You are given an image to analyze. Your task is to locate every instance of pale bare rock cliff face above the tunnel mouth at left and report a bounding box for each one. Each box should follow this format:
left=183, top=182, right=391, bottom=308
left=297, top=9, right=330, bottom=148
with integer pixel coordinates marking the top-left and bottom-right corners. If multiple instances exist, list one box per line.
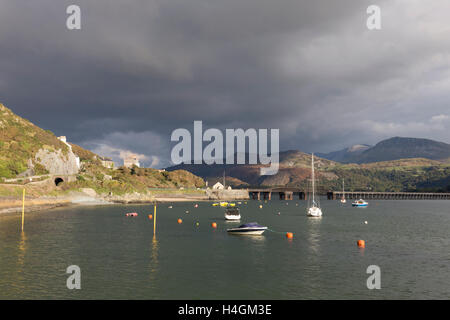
left=35, top=148, right=80, bottom=175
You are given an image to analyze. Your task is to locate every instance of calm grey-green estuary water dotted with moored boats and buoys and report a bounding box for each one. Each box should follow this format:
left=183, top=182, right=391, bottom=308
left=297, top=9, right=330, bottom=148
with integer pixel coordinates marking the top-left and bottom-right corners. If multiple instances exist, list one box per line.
left=0, top=200, right=450, bottom=299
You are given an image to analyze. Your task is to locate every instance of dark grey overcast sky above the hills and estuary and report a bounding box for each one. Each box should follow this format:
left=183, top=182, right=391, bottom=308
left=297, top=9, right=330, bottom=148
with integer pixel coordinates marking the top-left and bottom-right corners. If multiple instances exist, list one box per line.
left=0, top=0, right=450, bottom=167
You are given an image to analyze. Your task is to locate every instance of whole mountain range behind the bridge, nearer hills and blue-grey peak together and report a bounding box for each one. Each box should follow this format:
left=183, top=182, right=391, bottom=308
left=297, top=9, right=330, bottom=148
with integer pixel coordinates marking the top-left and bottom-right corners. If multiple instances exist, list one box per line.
left=167, top=137, right=450, bottom=191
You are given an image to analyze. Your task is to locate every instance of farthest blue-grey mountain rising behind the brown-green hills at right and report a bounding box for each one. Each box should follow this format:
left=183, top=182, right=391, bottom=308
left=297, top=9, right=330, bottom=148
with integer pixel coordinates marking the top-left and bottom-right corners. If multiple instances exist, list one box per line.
left=317, top=137, right=450, bottom=163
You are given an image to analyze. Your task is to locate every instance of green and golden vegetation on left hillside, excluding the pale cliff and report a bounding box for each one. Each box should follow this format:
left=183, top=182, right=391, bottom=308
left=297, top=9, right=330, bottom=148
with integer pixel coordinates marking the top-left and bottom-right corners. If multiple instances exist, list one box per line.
left=0, top=104, right=205, bottom=196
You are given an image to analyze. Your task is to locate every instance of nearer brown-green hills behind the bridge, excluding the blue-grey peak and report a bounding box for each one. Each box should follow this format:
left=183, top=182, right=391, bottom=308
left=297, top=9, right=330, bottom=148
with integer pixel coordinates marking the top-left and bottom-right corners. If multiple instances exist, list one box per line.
left=168, top=151, right=450, bottom=192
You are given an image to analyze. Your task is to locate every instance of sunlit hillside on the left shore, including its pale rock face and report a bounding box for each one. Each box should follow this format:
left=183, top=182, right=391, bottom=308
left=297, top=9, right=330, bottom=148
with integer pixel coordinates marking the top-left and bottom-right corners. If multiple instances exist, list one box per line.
left=0, top=104, right=205, bottom=196
